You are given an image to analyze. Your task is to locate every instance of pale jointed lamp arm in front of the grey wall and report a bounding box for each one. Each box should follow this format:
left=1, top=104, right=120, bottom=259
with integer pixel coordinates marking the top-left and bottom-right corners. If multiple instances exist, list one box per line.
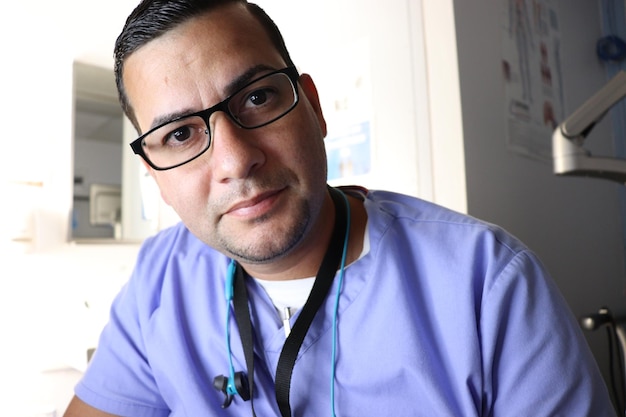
left=552, top=71, right=626, bottom=184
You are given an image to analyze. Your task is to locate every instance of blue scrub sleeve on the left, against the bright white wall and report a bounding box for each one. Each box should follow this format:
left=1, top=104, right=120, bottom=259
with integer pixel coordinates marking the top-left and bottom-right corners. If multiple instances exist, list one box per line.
left=75, top=264, right=170, bottom=417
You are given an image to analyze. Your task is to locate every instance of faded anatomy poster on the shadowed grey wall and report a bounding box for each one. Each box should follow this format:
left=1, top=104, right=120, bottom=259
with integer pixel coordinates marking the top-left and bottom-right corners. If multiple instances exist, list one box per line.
left=502, top=0, right=563, bottom=161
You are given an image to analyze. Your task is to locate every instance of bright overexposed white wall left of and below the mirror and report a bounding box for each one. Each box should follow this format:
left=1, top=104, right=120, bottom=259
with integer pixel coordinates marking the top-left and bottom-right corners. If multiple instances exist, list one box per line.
left=0, top=2, right=137, bottom=417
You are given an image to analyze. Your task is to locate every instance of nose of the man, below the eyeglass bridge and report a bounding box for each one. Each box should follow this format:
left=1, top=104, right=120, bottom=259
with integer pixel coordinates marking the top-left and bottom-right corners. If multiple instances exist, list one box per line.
left=209, top=112, right=266, bottom=182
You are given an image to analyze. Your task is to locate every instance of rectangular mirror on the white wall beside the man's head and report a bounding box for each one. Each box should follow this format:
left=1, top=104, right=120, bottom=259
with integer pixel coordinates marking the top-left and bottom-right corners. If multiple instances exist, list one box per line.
left=70, top=62, right=124, bottom=240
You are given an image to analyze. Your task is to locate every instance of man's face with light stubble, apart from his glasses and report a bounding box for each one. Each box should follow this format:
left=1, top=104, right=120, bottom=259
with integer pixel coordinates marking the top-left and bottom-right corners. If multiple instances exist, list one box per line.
left=123, top=5, right=326, bottom=263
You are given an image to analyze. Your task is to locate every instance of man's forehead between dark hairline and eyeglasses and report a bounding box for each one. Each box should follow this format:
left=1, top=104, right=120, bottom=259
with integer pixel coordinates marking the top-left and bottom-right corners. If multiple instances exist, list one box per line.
left=123, top=4, right=285, bottom=131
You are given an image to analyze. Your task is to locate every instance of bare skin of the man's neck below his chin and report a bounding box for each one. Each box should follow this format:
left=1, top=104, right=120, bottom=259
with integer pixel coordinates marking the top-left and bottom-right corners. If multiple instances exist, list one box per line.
left=241, top=188, right=367, bottom=281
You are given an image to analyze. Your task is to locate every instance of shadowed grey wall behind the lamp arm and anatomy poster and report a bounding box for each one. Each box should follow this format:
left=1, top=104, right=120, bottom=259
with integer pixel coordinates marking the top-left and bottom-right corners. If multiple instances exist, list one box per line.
left=454, top=0, right=626, bottom=386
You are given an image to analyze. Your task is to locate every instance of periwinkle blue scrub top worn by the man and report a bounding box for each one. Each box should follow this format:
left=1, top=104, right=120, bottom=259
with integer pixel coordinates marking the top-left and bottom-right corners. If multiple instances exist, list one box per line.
left=76, top=191, right=614, bottom=417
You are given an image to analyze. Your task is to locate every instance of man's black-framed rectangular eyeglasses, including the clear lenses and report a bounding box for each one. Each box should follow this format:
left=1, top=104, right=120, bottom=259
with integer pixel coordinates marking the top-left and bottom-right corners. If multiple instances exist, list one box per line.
left=130, top=67, right=298, bottom=171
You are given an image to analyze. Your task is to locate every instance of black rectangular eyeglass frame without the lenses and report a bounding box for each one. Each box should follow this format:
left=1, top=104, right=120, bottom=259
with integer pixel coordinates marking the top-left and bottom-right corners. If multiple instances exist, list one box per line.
left=130, top=66, right=300, bottom=171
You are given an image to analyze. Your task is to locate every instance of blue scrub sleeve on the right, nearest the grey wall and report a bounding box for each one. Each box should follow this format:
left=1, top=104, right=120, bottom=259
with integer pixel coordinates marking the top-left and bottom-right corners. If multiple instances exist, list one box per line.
left=480, top=251, right=615, bottom=417
